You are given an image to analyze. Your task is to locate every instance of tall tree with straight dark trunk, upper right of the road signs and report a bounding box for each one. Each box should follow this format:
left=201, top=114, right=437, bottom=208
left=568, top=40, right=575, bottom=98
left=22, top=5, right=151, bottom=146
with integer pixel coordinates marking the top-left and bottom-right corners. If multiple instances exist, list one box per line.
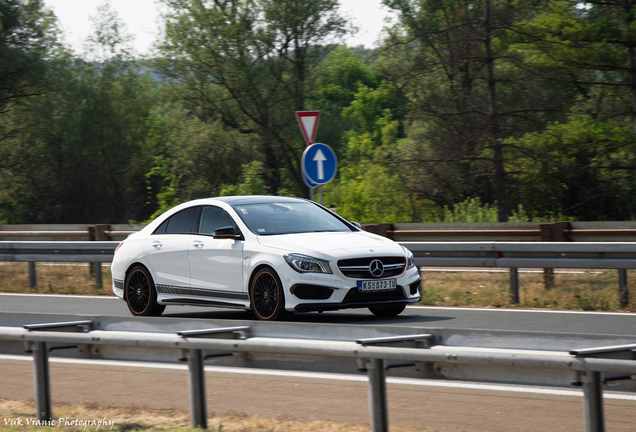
left=380, top=0, right=559, bottom=221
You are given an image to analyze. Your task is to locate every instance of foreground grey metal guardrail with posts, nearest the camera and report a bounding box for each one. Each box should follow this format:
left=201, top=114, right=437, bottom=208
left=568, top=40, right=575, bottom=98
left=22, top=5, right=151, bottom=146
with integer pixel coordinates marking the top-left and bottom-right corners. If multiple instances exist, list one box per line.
left=0, top=320, right=636, bottom=432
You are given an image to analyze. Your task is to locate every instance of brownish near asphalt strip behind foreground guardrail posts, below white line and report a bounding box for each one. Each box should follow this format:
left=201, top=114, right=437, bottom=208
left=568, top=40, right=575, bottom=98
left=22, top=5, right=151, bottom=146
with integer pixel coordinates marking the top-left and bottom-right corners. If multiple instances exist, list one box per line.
left=0, top=359, right=636, bottom=432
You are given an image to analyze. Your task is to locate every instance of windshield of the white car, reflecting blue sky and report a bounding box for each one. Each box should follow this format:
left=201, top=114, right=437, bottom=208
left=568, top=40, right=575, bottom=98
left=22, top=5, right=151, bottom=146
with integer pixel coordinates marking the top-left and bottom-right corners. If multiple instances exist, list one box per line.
left=234, top=202, right=351, bottom=235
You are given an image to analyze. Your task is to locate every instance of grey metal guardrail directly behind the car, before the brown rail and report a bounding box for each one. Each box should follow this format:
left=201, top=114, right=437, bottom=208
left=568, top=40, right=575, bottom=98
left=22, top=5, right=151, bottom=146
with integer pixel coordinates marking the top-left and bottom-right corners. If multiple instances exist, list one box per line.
left=0, top=241, right=636, bottom=307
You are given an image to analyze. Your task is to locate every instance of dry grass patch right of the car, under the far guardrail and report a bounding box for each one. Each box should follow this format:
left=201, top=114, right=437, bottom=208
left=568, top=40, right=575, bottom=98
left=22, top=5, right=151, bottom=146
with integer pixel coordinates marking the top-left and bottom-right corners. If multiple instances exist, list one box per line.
left=422, top=270, right=636, bottom=312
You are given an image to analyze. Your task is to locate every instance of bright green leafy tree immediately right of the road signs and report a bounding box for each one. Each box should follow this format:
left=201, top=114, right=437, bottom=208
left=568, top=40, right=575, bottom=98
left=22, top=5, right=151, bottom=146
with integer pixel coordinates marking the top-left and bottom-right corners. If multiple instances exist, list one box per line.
left=325, top=68, right=433, bottom=223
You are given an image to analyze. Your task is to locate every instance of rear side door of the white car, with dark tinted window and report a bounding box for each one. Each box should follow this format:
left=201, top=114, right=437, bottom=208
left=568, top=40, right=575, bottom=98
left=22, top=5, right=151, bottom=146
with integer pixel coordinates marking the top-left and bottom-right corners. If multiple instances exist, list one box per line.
left=144, top=206, right=200, bottom=295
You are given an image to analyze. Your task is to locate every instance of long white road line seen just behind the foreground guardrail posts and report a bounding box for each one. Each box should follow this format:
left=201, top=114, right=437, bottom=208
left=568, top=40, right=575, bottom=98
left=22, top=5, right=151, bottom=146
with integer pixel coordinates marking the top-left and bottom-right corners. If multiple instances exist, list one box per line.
left=0, top=354, right=636, bottom=401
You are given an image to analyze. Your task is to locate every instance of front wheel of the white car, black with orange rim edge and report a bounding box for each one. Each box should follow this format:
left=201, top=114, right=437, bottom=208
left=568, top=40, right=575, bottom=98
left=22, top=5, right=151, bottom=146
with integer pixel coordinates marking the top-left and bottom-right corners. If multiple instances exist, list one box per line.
left=250, top=267, right=291, bottom=321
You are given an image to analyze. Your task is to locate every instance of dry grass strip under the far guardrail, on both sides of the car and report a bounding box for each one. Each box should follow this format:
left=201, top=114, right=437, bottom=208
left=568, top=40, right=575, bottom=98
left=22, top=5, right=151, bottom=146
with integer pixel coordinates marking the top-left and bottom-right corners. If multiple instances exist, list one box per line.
left=0, top=263, right=636, bottom=312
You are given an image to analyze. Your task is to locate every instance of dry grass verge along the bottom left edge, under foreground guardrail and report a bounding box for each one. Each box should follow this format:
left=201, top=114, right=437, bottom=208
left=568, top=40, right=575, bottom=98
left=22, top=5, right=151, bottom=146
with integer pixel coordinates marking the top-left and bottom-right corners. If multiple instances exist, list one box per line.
left=0, top=399, right=424, bottom=432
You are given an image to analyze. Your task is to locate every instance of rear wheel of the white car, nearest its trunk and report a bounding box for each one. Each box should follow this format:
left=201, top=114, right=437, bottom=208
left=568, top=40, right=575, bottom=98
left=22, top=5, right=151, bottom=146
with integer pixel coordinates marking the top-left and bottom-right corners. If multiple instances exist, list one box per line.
left=124, top=265, right=166, bottom=316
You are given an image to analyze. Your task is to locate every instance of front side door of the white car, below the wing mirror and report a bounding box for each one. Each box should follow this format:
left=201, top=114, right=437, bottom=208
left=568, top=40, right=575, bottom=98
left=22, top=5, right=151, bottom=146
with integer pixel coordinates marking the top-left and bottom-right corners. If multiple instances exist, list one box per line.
left=188, top=206, right=248, bottom=302
